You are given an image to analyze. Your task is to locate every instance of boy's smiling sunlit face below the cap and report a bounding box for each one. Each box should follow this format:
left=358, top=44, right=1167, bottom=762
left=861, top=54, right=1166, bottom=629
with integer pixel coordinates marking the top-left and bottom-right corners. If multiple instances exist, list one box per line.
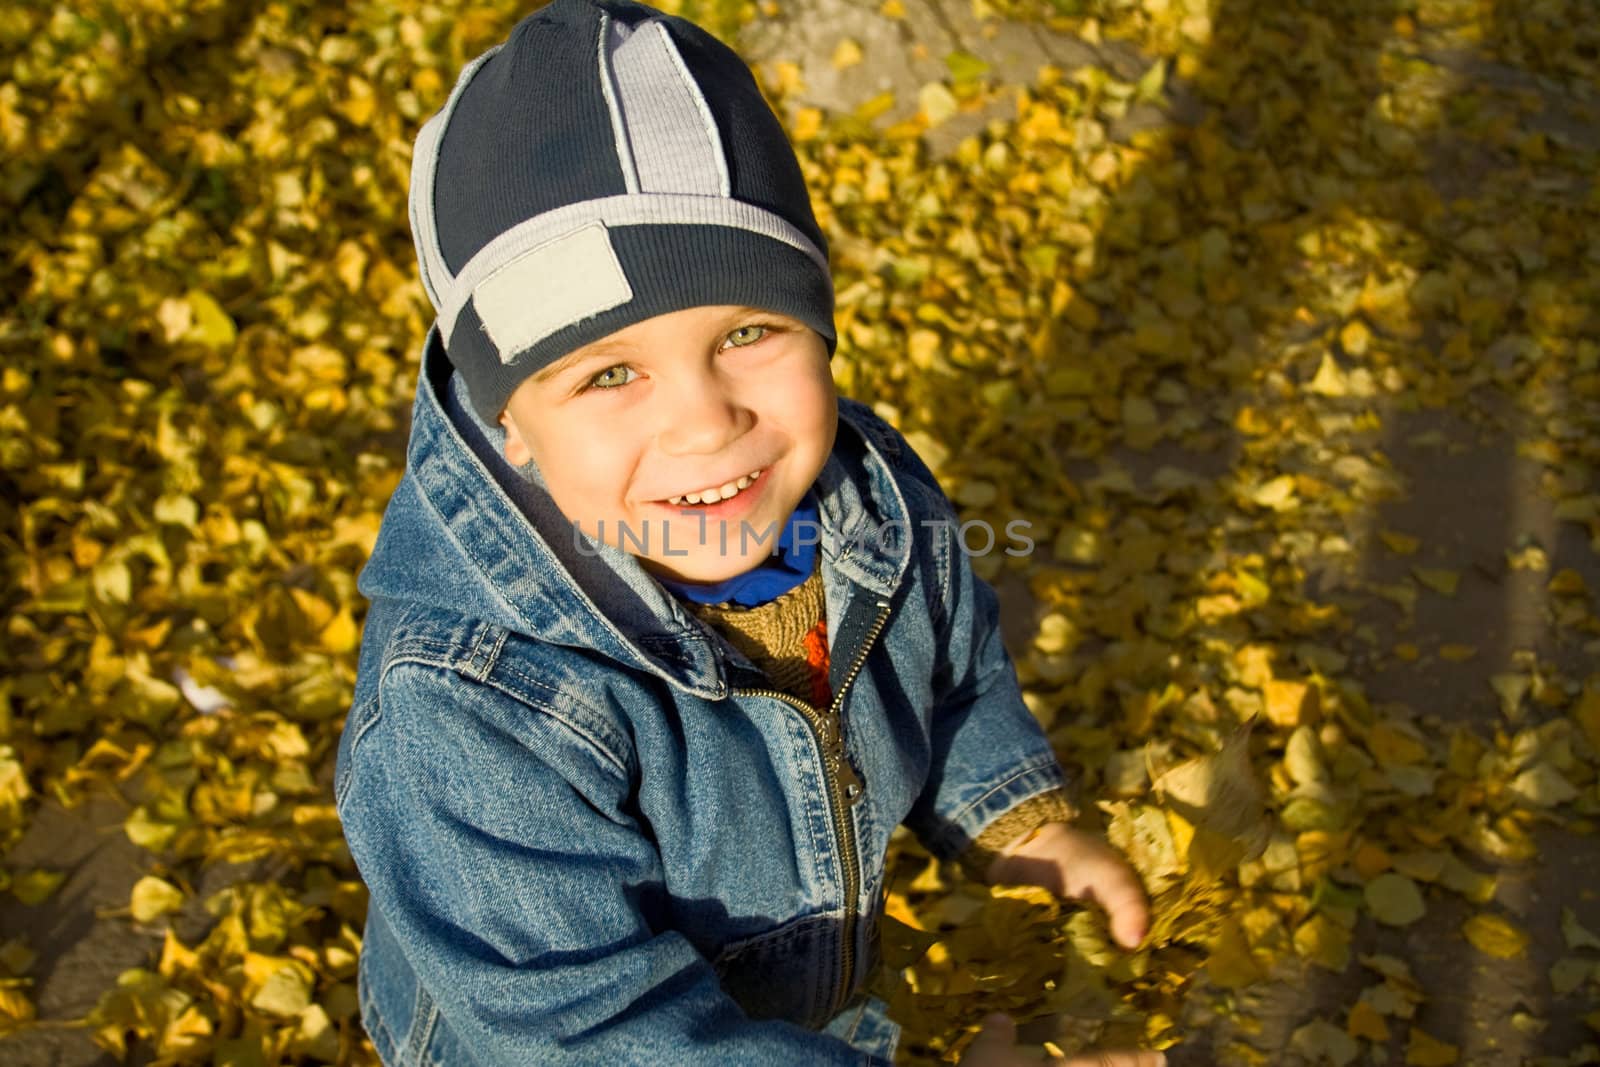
left=501, top=306, right=838, bottom=582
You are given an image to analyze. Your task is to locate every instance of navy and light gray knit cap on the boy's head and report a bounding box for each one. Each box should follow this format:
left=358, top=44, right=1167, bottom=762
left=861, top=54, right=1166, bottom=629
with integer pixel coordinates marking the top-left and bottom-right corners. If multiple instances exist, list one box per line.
left=411, top=0, right=835, bottom=422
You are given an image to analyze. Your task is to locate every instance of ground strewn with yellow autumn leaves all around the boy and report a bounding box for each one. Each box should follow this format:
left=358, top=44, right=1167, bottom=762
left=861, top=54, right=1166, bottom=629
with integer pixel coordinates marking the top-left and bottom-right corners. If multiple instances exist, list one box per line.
left=0, top=0, right=1600, bottom=1065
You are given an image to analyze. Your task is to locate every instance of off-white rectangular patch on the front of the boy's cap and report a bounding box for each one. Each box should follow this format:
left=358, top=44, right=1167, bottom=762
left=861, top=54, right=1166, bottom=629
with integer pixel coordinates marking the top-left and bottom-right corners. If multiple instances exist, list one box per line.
left=472, top=222, right=634, bottom=363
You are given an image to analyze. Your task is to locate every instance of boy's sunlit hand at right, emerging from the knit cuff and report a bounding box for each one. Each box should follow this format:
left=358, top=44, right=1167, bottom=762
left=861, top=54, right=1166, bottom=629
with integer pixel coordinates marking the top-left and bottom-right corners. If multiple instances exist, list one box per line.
left=986, top=822, right=1150, bottom=953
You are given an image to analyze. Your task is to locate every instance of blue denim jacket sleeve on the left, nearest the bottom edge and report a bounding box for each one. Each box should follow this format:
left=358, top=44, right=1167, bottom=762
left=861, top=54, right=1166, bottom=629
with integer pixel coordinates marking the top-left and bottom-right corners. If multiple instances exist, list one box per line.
left=339, top=664, right=877, bottom=1067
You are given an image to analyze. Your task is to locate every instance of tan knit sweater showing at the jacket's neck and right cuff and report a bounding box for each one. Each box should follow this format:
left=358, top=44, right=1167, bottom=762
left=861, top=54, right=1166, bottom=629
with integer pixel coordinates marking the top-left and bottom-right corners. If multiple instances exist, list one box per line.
left=683, top=569, right=1077, bottom=880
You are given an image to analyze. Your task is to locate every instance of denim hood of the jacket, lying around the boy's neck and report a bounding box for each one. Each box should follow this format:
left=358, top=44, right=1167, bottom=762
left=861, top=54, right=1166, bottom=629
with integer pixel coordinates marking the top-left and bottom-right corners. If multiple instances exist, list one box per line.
left=358, top=330, right=910, bottom=701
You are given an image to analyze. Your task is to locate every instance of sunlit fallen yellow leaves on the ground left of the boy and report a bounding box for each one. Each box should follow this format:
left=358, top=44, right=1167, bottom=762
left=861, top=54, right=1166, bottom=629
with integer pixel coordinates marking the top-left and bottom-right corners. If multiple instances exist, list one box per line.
left=0, top=0, right=534, bottom=1064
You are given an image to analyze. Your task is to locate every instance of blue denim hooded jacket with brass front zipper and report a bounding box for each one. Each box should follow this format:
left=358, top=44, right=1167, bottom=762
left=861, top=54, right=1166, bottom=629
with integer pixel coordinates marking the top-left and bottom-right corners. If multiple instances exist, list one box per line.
left=334, top=334, right=1062, bottom=1067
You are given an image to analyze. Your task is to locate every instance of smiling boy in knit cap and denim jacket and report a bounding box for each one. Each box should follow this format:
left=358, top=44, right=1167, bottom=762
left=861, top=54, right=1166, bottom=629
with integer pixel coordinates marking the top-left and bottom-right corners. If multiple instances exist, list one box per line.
left=336, top=0, right=1158, bottom=1065
